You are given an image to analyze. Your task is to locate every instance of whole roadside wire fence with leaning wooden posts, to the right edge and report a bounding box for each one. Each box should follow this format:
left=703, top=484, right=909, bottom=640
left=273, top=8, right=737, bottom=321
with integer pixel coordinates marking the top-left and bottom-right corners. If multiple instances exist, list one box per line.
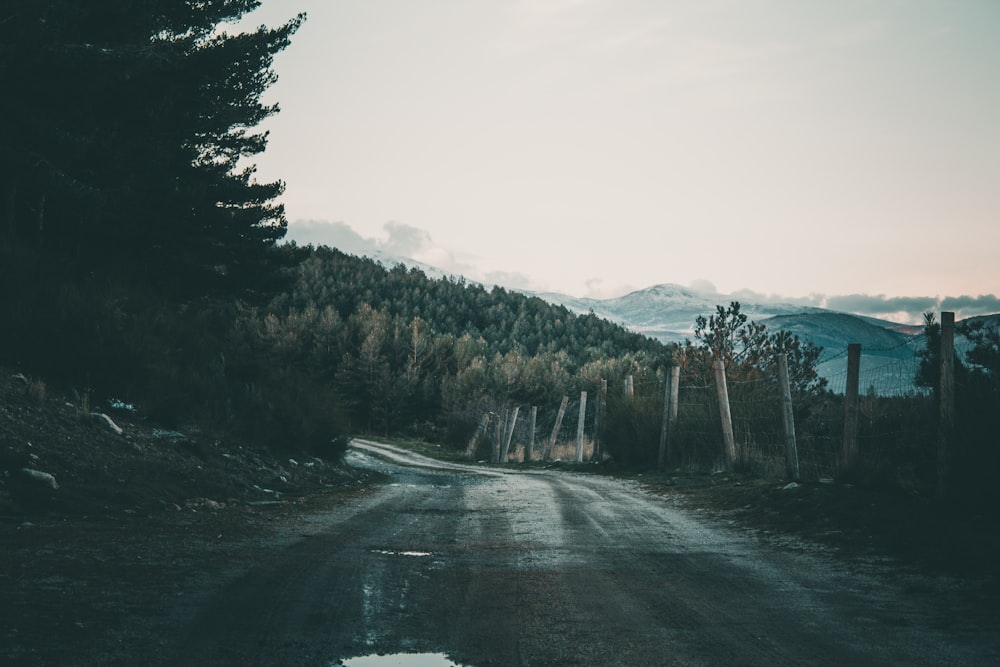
left=470, top=318, right=1000, bottom=500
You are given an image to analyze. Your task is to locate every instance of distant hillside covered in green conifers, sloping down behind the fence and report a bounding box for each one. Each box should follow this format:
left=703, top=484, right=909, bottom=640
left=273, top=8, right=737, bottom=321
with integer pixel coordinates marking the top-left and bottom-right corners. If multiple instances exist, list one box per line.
left=254, top=248, right=669, bottom=445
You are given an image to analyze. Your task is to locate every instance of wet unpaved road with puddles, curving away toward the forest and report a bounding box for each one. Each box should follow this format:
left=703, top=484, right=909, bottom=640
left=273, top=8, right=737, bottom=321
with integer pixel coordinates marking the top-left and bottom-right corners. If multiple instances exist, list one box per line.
left=169, top=441, right=1000, bottom=667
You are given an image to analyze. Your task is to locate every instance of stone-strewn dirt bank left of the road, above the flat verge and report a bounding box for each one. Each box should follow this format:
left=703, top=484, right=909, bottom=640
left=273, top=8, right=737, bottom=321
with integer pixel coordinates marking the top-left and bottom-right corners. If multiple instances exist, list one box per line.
left=0, top=368, right=360, bottom=519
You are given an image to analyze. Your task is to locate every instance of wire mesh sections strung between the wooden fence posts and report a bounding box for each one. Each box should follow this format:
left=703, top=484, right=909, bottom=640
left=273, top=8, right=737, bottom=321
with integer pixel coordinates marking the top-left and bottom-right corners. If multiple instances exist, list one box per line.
left=470, top=343, right=934, bottom=481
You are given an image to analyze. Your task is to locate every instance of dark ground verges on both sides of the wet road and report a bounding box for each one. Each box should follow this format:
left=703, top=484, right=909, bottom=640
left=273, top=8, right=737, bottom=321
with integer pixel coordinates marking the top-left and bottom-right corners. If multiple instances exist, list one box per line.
left=0, top=370, right=1000, bottom=665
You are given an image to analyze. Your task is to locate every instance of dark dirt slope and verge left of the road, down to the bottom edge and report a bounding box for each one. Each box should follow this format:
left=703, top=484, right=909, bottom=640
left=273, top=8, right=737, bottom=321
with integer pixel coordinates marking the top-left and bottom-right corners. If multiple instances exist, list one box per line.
left=0, top=367, right=367, bottom=665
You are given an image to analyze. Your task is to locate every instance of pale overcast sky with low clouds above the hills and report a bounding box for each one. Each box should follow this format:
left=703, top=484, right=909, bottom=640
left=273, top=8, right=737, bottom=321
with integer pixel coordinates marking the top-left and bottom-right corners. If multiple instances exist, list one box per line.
left=236, top=0, right=1000, bottom=321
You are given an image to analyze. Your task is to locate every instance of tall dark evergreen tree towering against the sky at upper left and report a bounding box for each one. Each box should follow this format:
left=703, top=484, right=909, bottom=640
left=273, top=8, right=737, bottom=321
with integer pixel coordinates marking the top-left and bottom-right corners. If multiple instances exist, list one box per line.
left=0, top=0, right=304, bottom=291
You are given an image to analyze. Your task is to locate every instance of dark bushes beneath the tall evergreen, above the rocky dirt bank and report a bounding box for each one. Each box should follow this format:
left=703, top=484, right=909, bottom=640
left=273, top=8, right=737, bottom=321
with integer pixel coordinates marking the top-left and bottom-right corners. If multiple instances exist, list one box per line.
left=0, top=250, right=346, bottom=460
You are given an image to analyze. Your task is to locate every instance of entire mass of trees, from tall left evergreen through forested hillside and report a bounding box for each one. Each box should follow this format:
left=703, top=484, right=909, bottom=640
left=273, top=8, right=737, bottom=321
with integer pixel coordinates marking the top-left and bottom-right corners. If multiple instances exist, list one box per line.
left=0, top=0, right=680, bottom=464
